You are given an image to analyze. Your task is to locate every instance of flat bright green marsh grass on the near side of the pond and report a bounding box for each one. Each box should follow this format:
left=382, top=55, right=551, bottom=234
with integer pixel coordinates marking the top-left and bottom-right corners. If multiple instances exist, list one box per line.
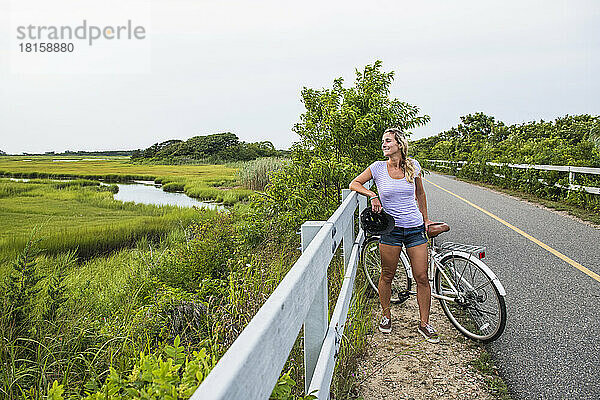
left=0, top=179, right=211, bottom=275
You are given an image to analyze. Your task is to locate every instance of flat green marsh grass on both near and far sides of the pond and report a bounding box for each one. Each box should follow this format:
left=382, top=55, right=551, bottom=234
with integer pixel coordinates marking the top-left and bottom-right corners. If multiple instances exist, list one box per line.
left=0, top=157, right=252, bottom=266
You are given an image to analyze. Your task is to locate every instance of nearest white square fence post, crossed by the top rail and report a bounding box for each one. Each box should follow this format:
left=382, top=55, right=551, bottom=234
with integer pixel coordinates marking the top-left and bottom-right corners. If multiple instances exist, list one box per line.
left=300, top=221, right=329, bottom=391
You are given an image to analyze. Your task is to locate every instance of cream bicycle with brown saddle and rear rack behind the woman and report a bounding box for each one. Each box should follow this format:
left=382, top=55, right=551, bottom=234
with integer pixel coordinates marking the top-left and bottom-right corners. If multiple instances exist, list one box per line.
left=361, top=223, right=506, bottom=343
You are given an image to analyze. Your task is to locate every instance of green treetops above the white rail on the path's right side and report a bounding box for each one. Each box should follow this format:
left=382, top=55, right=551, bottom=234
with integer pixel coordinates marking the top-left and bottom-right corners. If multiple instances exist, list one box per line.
left=412, top=113, right=600, bottom=166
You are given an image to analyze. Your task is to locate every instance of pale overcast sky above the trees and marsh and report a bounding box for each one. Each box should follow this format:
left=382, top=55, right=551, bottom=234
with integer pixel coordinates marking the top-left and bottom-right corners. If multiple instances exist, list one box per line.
left=0, top=0, right=600, bottom=153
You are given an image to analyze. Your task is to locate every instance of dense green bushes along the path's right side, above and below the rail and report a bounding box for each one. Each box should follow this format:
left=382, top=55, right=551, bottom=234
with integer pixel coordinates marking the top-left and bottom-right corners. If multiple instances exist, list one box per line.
left=411, top=113, right=600, bottom=214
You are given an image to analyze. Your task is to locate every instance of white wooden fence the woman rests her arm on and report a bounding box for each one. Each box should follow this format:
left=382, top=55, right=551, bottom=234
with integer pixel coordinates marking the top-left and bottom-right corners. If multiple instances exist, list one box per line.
left=191, top=183, right=370, bottom=400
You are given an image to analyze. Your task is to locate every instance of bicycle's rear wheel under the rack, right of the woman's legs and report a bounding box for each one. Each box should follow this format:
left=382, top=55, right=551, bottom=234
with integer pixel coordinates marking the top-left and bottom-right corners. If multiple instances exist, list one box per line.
left=434, top=253, right=506, bottom=343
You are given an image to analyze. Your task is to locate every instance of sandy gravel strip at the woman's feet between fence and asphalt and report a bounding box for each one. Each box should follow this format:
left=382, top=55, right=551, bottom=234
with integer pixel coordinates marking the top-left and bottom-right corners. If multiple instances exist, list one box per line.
left=359, top=296, right=494, bottom=400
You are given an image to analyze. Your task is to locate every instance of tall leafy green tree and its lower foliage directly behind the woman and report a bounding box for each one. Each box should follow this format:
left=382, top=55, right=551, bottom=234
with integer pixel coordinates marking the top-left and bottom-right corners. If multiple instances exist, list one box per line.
left=264, top=61, right=429, bottom=226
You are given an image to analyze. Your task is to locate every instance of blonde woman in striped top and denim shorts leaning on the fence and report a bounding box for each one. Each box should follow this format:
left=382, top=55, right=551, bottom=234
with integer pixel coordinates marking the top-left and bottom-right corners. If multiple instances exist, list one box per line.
left=350, top=128, right=439, bottom=343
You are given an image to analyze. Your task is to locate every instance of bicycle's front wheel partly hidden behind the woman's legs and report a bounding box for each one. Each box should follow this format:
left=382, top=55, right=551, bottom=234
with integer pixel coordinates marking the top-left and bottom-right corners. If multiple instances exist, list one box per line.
left=361, top=237, right=412, bottom=304
